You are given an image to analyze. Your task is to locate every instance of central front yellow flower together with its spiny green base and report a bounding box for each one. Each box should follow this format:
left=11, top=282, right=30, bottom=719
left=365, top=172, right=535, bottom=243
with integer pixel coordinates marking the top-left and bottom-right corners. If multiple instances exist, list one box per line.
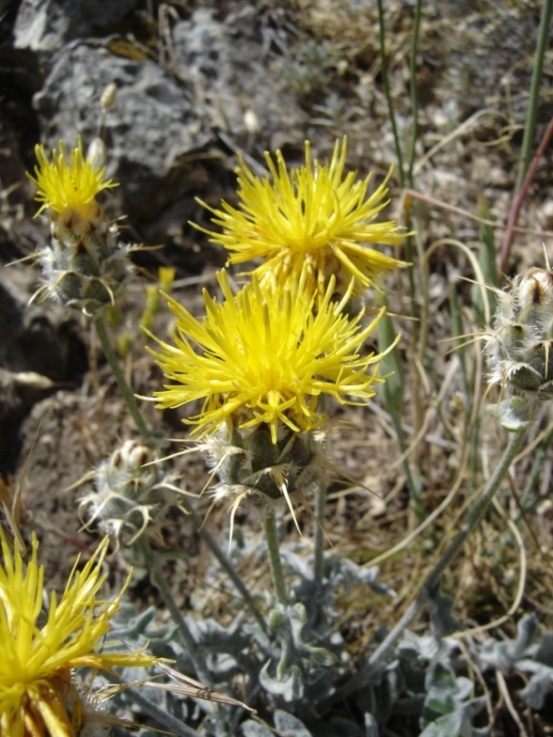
left=149, top=270, right=394, bottom=540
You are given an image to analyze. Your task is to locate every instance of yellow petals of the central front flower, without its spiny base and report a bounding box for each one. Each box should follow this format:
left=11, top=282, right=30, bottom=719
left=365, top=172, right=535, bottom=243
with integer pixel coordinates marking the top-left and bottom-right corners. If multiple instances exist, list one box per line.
left=152, top=271, right=394, bottom=443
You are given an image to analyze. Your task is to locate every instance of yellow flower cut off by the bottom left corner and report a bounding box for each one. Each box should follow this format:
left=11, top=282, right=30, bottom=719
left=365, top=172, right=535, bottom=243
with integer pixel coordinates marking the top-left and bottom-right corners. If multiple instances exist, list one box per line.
left=0, top=531, right=156, bottom=737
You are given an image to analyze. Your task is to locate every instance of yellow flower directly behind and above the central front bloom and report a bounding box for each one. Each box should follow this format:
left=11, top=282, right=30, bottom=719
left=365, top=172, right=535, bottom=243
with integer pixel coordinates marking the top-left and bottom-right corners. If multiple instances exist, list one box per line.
left=195, top=138, right=408, bottom=299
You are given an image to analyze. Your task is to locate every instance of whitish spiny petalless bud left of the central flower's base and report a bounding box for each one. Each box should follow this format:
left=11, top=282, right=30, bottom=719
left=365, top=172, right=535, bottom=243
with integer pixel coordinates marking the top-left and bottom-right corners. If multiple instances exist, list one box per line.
left=79, top=440, right=183, bottom=545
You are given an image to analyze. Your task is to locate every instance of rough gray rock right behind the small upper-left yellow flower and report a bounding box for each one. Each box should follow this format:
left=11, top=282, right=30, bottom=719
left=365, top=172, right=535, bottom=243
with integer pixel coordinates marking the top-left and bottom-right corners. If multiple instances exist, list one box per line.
left=34, top=42, right=210, bottom=207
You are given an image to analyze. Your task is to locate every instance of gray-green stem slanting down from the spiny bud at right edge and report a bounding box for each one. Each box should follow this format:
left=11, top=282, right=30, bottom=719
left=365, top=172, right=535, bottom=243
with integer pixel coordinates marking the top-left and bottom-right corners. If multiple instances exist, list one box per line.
left=367, top=428, right=526, bottom=670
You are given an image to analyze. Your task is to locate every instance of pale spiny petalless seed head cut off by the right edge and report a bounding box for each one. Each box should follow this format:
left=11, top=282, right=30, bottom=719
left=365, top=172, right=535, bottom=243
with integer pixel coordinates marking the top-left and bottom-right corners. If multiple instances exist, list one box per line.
left=486, top=268, right=553, bottom=399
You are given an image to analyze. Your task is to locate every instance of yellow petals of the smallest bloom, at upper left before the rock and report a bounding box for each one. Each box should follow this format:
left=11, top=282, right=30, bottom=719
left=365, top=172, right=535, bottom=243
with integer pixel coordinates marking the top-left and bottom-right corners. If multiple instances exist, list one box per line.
left=27, top=136, right=117, bottom=218
